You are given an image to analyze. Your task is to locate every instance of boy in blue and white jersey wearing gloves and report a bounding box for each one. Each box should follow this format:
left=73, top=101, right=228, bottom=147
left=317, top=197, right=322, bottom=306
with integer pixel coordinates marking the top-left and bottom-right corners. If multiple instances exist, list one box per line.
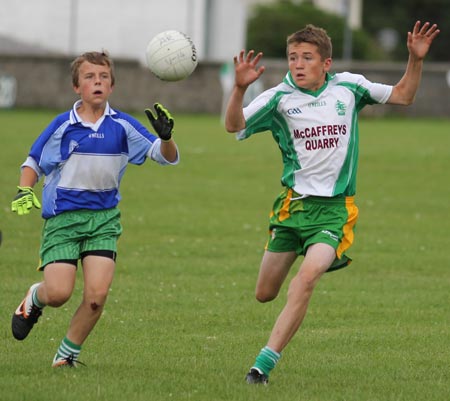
left=11, top=52, right=179, bottom=367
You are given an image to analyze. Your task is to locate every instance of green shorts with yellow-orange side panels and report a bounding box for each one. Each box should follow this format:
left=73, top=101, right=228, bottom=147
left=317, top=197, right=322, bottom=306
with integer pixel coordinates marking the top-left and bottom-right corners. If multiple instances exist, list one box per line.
left=265, top=189, right=358, bottom=271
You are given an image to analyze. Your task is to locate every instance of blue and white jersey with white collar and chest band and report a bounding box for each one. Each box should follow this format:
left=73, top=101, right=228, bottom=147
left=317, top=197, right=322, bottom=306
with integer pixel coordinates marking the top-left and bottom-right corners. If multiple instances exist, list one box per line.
left=22, top=101, right=179, bottom=219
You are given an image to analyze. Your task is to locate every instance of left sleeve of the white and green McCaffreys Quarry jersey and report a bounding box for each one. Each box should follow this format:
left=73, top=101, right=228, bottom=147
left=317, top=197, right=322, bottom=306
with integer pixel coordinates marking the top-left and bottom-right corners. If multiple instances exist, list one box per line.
left=236, top=88, right=277, bottom=140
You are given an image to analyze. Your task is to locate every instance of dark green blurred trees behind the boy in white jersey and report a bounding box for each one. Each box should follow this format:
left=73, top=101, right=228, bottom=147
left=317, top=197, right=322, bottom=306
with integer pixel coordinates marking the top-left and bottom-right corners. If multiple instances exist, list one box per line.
left=246, top=0, right=450, bottom=61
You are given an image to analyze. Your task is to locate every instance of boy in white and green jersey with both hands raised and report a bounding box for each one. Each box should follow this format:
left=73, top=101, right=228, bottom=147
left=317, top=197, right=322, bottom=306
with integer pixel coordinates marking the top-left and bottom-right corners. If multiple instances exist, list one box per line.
left=225, top=21, right=439, bottom=384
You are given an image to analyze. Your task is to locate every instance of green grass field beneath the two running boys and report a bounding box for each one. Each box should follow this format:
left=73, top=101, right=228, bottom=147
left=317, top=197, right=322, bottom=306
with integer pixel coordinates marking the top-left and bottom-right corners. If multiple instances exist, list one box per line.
left=0, top=110, right=450, bottom=401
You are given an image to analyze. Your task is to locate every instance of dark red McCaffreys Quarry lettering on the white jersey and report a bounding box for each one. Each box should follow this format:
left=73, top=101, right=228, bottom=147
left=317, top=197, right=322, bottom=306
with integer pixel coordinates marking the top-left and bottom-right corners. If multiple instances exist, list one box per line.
left=294, top=124, right=347, bottom=150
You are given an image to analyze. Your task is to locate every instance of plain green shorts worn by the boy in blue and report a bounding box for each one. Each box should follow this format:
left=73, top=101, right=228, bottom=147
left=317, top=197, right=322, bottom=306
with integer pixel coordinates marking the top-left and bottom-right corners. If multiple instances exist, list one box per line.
left=38, top=208, right=122, bottom=270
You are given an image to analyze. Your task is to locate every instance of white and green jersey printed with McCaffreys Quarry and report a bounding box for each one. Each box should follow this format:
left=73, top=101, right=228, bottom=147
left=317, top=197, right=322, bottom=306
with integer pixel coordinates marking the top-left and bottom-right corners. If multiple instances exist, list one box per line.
left=237, top=72, right=392, bottom=197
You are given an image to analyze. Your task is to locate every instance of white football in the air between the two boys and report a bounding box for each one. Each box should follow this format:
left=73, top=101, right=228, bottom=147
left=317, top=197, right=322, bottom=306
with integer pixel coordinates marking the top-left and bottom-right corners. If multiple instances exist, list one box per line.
left=146, top=30, right=198, bottom=81
